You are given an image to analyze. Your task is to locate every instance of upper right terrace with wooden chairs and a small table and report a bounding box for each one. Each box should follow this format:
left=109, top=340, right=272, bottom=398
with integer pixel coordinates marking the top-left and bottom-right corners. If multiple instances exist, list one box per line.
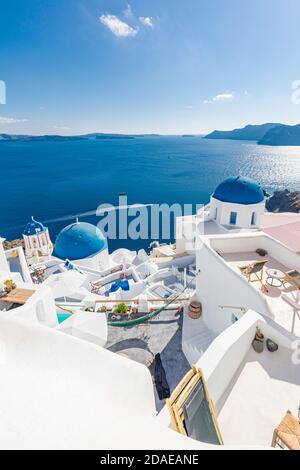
left=210, top=233, right=300, bottom=336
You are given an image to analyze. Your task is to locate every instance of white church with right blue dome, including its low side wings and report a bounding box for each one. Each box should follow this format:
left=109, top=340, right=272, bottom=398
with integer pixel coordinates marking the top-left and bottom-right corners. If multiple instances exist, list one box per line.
left=176, top=176, right=300, bottom=254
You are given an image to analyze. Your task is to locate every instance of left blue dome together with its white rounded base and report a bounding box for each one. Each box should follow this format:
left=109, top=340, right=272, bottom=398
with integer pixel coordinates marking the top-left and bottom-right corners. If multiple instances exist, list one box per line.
left=54, top=220, right=109, bottom=270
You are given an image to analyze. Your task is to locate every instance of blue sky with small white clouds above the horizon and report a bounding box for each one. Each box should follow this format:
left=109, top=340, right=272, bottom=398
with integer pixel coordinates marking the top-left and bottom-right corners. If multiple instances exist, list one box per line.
left=0, top=0, right=300, bottom=134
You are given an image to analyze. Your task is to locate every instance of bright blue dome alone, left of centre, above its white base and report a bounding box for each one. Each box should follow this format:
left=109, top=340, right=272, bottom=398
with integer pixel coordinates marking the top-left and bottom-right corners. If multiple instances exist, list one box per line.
left=54, top=222, right=107, bottom=261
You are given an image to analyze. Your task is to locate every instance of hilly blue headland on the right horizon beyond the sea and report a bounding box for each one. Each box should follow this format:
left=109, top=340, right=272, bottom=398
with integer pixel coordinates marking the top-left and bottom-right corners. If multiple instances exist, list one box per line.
left=205, top=123, right=300, bottom=146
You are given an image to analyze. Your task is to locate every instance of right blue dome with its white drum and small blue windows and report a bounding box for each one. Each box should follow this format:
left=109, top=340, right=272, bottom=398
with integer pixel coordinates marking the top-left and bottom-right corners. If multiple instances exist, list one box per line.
left=210, top=176, right=265, bottom=229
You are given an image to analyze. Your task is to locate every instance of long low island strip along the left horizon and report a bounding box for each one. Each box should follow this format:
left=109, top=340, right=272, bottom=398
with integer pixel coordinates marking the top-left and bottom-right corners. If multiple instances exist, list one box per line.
left=0, top=132, right=159, bottom=142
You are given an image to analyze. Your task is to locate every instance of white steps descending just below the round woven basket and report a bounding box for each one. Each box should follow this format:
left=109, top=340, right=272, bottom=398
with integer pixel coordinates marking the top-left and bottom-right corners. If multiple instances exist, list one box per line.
left=183, top=318, right=217, bottom=365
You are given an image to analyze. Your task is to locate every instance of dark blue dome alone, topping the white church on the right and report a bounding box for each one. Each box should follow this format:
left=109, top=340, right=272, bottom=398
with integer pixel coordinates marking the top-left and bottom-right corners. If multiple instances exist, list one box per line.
left=213, top=176, right=265, bottom=204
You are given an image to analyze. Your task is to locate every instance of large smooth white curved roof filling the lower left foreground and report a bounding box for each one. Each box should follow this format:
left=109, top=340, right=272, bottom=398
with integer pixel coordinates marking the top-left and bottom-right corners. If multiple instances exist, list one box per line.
left=0, top=313, right=203, bottom=449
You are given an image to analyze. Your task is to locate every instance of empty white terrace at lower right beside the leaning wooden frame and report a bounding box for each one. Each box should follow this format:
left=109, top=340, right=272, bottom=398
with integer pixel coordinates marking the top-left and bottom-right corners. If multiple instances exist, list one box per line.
left=217, top=347, right=300, bottom=446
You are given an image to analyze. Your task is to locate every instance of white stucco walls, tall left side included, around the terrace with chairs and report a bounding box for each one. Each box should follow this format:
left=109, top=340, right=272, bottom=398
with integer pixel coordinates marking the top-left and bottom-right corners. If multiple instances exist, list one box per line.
left=195, top=232, right=300, bottom=336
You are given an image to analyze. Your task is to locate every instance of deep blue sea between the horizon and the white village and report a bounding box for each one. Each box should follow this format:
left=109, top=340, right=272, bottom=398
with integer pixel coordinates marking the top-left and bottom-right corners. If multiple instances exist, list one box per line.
left=0, top=136, right=300, bottom=249
